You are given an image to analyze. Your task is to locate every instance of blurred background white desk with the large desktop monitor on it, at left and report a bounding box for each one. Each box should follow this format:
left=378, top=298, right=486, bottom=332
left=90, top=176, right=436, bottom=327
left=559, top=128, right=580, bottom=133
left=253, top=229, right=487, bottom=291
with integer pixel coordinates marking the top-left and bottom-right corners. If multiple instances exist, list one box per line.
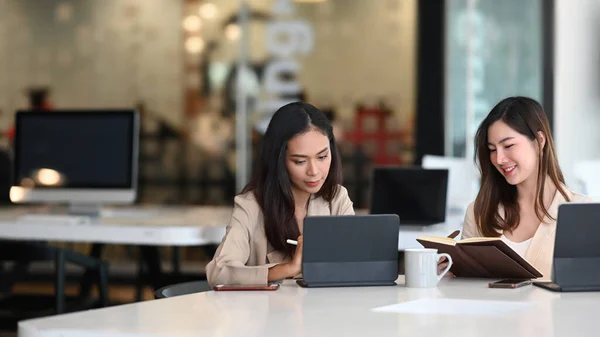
left=0, top=109, right=231, bottom=313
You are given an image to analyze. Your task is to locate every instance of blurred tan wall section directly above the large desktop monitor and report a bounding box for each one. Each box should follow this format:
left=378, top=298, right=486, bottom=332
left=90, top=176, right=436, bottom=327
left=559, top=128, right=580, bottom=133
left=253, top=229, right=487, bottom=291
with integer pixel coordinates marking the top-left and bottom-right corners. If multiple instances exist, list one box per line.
left=0, top=0, right=184, bottom=129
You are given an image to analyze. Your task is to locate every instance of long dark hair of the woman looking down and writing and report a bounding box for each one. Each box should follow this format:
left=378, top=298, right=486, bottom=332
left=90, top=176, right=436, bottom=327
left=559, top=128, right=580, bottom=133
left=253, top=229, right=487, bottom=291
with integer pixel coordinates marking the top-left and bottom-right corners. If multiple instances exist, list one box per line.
left=242, top=102, right=342, bottom=257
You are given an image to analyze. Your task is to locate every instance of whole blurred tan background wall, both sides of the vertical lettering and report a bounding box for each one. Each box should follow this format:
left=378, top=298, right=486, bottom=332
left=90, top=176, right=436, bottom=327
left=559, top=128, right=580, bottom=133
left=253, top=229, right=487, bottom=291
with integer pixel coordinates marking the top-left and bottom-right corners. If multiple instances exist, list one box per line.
left=0, top=0, right=417, bottom=130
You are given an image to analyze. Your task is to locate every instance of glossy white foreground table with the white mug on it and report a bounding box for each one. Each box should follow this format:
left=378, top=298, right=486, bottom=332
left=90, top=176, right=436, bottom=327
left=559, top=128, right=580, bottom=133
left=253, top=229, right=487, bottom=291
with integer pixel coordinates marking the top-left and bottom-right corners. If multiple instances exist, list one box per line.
left=19, top=277, right=600, bottom=337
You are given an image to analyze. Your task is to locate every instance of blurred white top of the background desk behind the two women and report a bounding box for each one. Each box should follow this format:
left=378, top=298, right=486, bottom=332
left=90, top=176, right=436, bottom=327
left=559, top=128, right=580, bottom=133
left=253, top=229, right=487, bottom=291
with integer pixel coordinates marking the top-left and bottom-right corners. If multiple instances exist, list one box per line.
left=0, top=206, right=464, bottom=250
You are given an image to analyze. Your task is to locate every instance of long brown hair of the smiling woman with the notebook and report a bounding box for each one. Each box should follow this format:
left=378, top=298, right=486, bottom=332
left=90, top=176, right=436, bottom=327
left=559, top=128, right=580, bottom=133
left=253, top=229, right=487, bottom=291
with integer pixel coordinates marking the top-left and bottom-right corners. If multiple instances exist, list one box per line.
left=474, top=97, right=569, bottom=236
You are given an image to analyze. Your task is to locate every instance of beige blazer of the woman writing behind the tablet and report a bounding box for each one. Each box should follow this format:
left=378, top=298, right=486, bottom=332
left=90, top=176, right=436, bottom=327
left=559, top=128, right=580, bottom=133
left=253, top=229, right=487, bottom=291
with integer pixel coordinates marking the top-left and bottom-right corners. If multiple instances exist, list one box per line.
left=206, top=186, right=354, bottom=286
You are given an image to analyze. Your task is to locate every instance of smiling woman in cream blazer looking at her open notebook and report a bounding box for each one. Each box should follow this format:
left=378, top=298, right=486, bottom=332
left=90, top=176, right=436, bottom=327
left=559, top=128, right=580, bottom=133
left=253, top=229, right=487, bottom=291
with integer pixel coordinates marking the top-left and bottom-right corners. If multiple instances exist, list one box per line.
left=463, top=97, right=591, bottom=279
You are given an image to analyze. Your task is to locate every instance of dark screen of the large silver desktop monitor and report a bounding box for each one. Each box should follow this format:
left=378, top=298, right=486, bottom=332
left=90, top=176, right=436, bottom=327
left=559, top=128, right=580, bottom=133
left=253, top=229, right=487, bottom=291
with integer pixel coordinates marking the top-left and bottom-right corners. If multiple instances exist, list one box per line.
left=13, top=110, right=137, bottom=189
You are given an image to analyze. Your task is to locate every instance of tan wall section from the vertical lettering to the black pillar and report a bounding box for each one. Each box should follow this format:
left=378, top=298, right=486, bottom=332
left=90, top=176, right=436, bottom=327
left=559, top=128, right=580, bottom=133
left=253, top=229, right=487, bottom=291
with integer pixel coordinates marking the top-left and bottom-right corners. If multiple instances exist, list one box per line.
left=198, top=0, right=417, bottom=119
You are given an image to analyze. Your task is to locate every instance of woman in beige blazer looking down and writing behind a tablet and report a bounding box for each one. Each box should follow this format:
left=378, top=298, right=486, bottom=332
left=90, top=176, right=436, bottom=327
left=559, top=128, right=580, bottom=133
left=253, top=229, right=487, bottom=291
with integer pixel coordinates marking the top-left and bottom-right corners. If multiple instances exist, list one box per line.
left=206, top=102, right=354, bottom=286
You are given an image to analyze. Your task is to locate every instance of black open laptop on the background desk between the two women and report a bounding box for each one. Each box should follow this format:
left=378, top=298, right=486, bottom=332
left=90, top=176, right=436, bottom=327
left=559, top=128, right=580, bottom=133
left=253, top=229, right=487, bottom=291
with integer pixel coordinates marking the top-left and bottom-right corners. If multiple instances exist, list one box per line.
left=370, top=167, right=448, bottom=226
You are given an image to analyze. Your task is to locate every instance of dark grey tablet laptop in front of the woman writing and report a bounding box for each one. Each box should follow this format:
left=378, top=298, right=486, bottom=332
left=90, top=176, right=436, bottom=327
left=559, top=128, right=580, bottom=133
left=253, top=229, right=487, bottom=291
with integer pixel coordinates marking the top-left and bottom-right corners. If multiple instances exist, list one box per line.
left=297, top=214, right=400, bottom=288
